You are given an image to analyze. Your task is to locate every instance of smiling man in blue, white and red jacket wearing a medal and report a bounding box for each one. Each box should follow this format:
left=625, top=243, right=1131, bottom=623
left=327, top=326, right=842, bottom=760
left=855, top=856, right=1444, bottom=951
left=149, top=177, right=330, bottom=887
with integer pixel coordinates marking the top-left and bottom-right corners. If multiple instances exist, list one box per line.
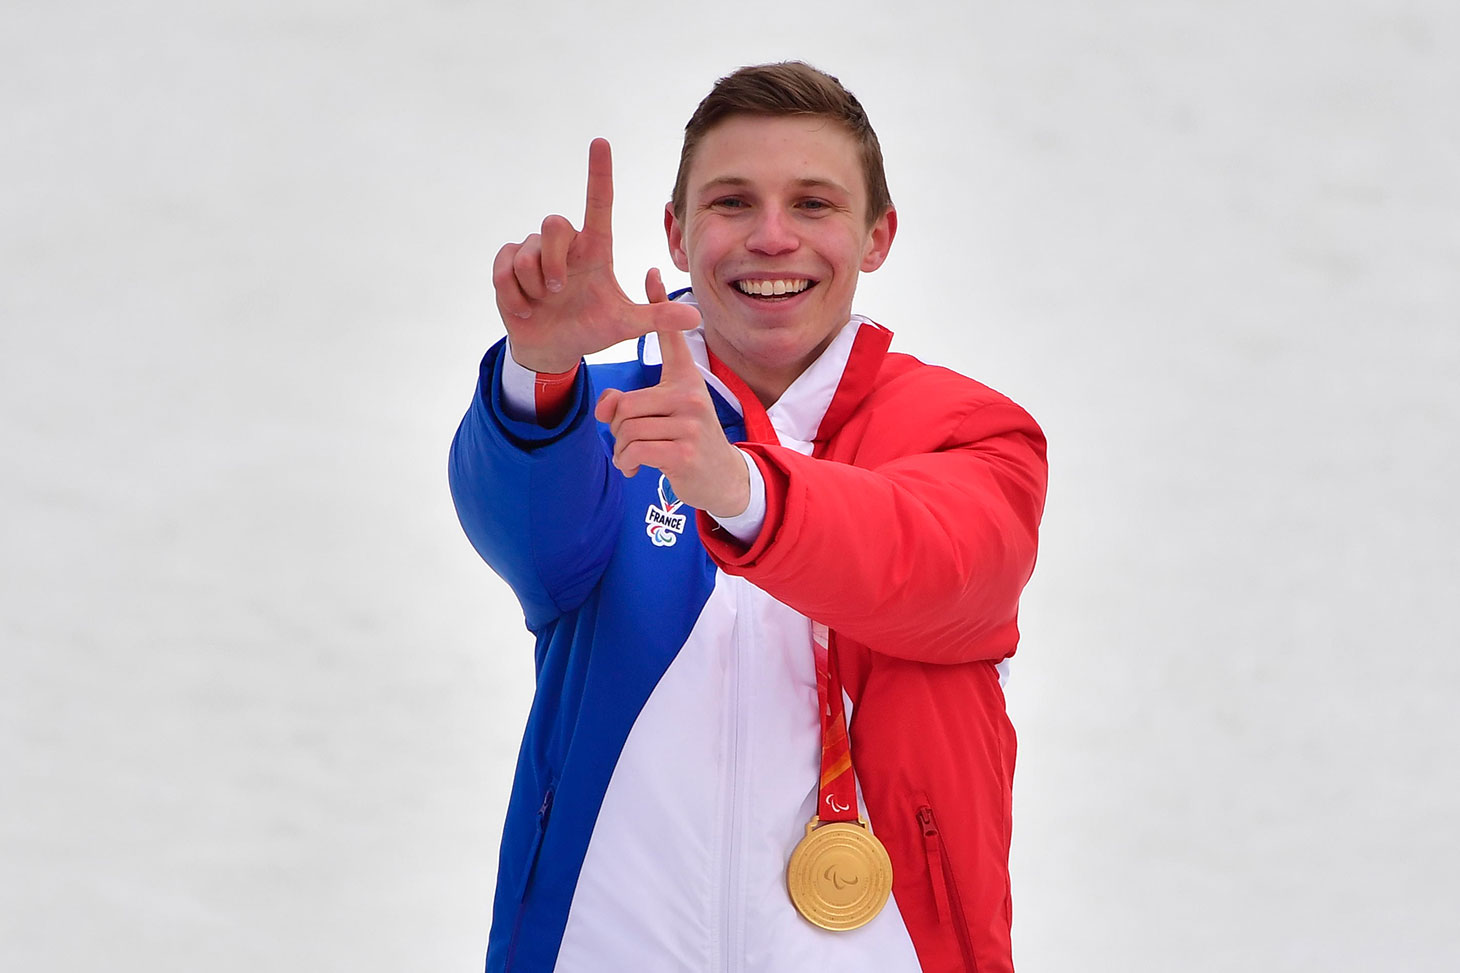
left=450, top=63, right=1045, bottom=973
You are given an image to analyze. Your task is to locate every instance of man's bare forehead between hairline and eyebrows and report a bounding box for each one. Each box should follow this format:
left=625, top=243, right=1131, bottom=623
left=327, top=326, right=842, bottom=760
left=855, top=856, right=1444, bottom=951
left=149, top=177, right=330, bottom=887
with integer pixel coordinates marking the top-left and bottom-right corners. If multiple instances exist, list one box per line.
left=688, top=115, right=864, bottom=196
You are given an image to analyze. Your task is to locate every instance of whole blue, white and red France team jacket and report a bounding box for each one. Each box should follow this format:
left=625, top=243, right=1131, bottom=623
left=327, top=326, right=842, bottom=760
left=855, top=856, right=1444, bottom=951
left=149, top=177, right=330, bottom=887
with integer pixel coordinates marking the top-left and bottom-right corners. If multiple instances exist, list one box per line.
left=450, top=312, right=1045, bottom=973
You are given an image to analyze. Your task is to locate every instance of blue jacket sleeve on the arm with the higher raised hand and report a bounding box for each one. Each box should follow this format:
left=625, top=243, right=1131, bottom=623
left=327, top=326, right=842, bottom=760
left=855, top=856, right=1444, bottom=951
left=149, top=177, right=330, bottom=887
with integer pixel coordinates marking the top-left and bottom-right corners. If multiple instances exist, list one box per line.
left=448, top=340, right=622, bottom=633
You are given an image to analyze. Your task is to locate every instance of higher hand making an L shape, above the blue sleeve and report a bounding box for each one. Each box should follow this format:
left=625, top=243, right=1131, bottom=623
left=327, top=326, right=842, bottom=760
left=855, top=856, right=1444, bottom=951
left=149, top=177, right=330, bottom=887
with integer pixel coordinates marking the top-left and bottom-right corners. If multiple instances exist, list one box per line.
left=492, top=139, right=699, bottom=373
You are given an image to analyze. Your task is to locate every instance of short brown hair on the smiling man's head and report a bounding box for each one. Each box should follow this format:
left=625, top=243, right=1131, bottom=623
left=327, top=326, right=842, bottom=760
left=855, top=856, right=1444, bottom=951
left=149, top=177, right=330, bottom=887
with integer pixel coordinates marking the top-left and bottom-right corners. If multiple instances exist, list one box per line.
left=670, top=61, right=892, bottom=226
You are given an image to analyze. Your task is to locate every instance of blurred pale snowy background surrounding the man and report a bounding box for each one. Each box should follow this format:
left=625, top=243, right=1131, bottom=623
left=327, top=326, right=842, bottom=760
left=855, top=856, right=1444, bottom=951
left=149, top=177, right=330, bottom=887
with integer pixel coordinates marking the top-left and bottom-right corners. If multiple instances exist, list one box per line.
left=0, top=0, right=1460, bottom=973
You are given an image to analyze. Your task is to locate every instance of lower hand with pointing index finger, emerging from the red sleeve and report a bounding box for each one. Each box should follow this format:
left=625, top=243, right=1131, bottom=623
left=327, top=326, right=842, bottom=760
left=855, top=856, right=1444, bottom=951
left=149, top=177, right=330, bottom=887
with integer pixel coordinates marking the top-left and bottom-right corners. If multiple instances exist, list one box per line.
left=593, top=269, right=750, bottom=517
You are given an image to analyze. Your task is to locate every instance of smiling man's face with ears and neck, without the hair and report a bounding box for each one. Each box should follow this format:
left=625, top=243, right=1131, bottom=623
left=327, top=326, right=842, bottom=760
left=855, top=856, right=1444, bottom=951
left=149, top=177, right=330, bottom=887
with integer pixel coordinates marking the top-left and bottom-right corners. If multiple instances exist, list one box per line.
left=664, top=108, right=898, bottom=405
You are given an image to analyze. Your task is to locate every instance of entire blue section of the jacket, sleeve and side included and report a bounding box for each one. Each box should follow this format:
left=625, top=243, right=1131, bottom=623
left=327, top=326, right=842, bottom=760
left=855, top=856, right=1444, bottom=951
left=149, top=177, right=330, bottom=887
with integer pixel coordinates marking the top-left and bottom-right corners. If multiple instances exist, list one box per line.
left=448, top=340, right=743, bottom=973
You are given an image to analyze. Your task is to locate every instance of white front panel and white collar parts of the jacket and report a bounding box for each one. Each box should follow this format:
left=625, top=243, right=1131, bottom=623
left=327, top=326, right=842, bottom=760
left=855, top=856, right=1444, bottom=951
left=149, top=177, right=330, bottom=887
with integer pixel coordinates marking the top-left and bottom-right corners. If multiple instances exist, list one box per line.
left=556, top=321, right=918, bottom=973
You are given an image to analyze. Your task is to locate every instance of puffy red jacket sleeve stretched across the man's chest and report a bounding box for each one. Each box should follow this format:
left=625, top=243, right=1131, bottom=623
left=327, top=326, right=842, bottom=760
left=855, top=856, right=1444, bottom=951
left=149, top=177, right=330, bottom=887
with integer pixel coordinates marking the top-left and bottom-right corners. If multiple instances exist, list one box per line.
left=701, top=399, right=1047, bottom=663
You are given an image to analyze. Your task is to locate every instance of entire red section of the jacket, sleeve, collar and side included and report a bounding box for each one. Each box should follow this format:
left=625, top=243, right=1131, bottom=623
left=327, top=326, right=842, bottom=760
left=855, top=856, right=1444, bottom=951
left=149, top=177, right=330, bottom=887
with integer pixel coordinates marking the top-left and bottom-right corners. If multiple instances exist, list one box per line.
left=699, top=336, right=1047, bottom=973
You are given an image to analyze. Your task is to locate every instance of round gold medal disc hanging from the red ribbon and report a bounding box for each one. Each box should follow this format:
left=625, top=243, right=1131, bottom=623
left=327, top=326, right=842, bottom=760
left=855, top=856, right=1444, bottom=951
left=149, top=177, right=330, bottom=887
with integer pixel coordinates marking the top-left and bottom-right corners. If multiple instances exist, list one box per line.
left=785, top=817, right=892, bottom=932
